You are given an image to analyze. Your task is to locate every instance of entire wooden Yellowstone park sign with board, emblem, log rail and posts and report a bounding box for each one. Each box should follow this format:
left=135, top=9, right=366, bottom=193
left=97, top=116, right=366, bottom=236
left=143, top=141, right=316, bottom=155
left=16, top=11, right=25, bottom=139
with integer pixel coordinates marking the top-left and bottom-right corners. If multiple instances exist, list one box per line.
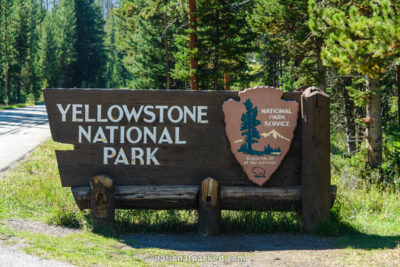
left=44, top=87, right=336, bottom=235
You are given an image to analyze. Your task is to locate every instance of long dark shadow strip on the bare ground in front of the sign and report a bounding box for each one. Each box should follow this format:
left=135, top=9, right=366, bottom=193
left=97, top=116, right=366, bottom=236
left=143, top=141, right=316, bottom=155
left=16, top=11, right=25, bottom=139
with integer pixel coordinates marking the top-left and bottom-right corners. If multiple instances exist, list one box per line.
left=116, top=226, right=400, bottom=252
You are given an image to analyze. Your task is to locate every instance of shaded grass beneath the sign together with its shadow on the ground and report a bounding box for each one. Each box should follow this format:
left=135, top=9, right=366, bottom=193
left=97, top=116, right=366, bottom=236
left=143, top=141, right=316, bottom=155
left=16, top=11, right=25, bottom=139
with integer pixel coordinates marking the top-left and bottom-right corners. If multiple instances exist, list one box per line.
left=54, top=210, right=400, bottom=252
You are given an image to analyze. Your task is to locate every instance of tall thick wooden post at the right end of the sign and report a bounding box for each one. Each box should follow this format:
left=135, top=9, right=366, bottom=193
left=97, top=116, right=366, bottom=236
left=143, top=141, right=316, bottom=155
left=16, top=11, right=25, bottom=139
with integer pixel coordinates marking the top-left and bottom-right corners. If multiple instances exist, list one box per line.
left=301, top=87, right=331, bottom=232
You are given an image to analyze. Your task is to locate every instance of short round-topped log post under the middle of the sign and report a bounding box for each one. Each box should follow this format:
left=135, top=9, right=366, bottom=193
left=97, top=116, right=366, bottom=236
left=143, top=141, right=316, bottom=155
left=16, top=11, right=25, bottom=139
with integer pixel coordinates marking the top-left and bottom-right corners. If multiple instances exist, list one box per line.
left=198, top=177, right=221, bottom=236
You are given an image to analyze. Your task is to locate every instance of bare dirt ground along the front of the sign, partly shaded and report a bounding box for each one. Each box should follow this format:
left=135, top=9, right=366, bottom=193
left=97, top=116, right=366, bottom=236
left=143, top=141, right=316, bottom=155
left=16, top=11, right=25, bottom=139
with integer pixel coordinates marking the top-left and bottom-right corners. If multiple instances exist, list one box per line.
left=0, top=220, right=400, bottom=267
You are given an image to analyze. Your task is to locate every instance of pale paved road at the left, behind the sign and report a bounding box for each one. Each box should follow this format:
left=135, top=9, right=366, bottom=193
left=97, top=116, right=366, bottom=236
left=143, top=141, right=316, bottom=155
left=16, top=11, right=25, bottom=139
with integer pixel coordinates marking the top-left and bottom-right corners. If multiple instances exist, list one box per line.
left=0, top=105, right=50, bottom=176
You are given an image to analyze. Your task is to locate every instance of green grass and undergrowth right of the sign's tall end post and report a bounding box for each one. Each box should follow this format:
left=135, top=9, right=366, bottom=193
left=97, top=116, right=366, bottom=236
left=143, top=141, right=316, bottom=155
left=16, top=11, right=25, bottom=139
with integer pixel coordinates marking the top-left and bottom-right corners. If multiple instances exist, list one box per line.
left=319, top=134, right=400, bottom=266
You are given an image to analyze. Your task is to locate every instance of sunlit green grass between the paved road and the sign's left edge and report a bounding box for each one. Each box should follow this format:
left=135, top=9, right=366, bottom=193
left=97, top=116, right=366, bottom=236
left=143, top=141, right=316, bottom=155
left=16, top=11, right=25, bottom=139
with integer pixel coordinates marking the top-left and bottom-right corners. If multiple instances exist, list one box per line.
left=0, top=142, right=77, bottom=221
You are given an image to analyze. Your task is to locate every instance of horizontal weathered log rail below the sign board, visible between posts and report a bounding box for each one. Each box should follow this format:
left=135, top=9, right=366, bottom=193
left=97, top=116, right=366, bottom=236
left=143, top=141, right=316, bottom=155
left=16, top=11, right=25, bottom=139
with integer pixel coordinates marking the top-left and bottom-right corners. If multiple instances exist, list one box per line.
left=71, top=185, right=337, bottom=210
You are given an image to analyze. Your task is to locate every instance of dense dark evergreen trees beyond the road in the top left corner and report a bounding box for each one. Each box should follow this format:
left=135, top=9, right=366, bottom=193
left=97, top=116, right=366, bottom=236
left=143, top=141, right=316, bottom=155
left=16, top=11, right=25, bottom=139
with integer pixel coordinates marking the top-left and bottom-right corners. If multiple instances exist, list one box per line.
left=0, top=0, right=109, bottom=99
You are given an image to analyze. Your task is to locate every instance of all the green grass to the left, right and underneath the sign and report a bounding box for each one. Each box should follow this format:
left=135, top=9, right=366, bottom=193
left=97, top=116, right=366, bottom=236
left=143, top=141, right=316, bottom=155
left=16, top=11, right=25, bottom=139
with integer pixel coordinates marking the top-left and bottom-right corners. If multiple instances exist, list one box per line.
left=0, top=137, right=400, bottom=266
